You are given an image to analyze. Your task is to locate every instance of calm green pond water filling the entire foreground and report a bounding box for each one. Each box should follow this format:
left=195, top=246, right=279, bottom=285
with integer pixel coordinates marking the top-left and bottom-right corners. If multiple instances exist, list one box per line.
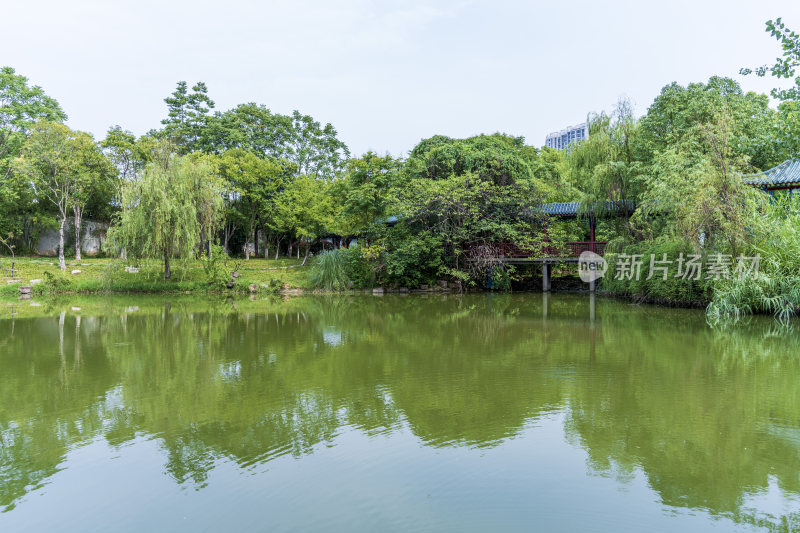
left=0, top=294, right=800, bottom=533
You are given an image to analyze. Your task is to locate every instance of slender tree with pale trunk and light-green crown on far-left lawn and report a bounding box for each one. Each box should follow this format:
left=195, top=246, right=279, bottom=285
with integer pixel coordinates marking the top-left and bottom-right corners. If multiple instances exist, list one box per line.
left=14, top=121, right=102, bottom=270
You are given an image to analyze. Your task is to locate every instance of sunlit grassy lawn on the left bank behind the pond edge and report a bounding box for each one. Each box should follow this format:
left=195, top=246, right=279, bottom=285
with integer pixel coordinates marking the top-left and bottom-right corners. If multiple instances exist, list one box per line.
left=0, top=252, right=311, bottom=296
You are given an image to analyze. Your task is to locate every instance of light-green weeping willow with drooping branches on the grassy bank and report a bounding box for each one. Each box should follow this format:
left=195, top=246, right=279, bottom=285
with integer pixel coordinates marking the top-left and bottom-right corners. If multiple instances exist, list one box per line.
left=109, top=154, right=223, bottom=280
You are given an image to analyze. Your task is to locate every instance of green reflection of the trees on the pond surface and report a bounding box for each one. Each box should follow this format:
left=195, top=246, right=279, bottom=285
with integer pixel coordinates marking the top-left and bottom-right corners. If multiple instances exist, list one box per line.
left=0, top=294, right=800, bottom=530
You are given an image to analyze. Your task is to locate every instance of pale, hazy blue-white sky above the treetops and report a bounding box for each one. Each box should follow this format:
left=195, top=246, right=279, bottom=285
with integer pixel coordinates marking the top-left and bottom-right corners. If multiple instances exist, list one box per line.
left=0, top=0, right=800, bottom=156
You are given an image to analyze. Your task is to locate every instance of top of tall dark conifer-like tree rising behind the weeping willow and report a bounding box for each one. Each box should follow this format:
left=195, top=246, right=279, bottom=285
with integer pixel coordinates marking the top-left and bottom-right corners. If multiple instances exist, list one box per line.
left=161, top=81, right=214, bottom=154
